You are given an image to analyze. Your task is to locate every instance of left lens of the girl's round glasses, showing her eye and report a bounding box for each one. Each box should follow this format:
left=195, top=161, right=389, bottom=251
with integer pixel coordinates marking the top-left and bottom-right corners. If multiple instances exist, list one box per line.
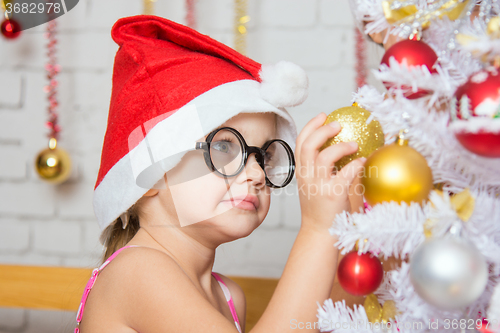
left=210, top=130, right=243, bottom=176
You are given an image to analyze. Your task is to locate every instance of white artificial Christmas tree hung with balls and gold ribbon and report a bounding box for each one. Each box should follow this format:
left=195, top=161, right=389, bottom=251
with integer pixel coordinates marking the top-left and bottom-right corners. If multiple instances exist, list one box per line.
left=317, top=0, right=500, bottom=332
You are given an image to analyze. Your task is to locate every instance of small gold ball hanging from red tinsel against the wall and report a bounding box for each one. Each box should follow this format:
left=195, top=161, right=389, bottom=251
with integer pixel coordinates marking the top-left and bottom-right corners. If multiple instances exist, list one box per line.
left=35, top=148, right=71, bottom=184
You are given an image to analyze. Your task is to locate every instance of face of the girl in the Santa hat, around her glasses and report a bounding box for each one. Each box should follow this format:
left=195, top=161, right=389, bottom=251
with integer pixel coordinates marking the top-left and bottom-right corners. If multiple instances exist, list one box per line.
left=146, top=113, right=276, bottom=243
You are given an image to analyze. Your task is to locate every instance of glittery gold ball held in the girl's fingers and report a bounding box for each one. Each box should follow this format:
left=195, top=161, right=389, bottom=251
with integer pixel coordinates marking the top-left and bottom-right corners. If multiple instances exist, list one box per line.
left=320, top=106, right=385, bottom=170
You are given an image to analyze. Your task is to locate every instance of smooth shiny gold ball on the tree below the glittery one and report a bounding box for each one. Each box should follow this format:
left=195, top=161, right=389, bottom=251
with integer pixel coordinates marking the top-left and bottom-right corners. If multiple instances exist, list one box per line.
left=361, top=142, right=432, bottom=206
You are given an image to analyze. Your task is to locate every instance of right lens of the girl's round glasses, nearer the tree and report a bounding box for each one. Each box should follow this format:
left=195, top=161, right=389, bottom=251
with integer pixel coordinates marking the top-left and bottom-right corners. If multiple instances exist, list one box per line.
left=264, top=141, right=292, bottom=186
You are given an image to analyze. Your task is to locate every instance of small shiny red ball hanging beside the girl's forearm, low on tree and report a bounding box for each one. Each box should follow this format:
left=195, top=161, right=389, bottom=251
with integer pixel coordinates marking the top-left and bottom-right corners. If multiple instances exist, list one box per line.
left=337, top=251, right=384, bottom=296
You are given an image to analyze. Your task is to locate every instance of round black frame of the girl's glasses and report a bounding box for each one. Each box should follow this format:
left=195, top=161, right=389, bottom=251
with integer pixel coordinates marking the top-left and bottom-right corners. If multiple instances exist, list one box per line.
left=195, top=127, right=295, bottom=188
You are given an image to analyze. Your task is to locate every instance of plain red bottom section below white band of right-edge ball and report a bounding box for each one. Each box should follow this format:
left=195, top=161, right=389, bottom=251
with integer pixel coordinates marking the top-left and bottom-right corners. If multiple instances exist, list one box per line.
left=455, top=132, right=500, bottom=157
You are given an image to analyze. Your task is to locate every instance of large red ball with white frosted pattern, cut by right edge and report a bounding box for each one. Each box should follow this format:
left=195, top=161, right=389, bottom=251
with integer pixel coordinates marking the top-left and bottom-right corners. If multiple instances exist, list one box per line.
left=451, top=70, right=500, bottom=157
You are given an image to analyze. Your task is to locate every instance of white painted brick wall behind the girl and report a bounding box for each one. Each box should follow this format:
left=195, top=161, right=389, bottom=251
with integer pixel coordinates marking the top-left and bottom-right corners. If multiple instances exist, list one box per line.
left=0, top=0, right=382, bottom=333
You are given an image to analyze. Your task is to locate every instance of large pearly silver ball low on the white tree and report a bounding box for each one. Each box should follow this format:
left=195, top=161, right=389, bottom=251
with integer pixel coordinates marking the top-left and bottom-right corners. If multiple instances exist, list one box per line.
left=410, top=237, right=488, bottom=310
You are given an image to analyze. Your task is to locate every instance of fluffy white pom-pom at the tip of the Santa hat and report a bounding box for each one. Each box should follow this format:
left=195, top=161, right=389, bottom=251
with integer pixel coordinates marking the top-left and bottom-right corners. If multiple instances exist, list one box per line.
left=259, top=61, right=309, bottom=108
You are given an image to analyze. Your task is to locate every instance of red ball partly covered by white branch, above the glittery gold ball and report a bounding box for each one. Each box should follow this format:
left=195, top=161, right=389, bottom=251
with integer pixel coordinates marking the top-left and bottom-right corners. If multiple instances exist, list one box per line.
left=380, top=40, right=438, bottom=99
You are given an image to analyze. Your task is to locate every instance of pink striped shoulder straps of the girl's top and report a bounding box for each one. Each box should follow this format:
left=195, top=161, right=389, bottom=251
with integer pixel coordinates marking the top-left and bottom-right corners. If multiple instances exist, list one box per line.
left=74, top=245, right=241, bottom=333
